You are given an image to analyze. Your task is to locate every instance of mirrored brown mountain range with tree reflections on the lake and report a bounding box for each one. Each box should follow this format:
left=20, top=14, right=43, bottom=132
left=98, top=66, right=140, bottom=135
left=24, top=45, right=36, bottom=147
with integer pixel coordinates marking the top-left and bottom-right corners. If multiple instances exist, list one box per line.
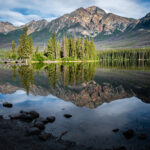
left=0, top=64, right=150, bottom=108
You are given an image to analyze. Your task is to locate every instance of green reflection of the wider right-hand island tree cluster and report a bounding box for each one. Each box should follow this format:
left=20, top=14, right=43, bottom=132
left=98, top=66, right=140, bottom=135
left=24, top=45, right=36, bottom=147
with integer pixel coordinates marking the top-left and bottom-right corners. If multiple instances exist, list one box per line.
left=45, top=63, right=96, bottom=88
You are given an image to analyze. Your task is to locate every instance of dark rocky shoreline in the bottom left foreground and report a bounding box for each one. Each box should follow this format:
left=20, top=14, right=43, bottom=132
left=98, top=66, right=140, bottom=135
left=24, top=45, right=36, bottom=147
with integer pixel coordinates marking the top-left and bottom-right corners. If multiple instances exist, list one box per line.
left=0, top=111, right=87, bottom=150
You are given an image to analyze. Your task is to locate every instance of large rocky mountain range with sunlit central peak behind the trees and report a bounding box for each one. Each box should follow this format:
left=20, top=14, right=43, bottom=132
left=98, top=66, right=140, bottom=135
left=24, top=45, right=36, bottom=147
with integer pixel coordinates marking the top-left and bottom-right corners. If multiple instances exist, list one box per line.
left=0, top=6, right=150, bottom=49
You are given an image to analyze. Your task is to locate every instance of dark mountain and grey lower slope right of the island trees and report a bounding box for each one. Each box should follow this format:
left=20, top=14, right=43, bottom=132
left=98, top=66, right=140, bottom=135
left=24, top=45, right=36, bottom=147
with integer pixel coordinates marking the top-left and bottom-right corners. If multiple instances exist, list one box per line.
left=95, top=13, right=150, bottom=49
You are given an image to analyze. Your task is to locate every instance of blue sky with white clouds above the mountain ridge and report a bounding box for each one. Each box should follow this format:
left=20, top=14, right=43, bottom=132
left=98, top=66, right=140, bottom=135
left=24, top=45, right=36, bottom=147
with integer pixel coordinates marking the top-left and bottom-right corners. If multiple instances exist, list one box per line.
left=0, top=0, right=150, bottom=26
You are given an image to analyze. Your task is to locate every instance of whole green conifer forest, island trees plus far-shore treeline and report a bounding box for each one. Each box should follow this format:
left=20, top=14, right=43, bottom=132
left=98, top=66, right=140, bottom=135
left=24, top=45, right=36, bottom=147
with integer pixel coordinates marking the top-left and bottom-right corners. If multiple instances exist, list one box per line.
left=0, top=27, right=150, bottom=62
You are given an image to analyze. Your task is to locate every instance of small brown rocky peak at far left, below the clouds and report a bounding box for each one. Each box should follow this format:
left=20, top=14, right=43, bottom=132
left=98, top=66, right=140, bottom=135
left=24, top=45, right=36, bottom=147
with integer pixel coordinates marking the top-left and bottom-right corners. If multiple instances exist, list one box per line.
left=0, top=22, right=16, bottom=34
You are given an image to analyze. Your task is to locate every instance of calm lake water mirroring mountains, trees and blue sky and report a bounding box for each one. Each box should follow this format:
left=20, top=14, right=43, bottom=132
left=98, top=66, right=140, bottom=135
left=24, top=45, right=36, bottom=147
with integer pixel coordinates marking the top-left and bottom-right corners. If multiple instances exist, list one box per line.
left=0, top=62, right=150, bottom=150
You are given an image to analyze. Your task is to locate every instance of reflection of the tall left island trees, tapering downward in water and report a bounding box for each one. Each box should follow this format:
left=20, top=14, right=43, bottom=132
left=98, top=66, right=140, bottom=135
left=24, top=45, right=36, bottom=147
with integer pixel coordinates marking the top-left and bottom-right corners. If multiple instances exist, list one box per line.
left=18, top=65, right=34, bottom=94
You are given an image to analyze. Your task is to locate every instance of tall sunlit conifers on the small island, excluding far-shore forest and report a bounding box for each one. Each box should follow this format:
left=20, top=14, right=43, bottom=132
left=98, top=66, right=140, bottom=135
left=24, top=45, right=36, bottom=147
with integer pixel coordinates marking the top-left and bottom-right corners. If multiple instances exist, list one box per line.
left=11, top=27, right=97, bottom=60
